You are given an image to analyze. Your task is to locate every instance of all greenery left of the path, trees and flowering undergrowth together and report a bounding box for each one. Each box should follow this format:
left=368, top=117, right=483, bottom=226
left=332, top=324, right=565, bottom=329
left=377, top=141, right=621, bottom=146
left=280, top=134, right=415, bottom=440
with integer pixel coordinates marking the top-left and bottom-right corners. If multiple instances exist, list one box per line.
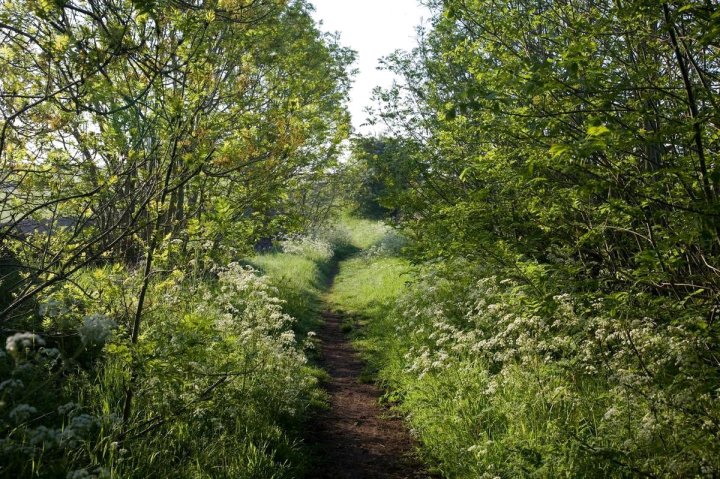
left=0, top=0, right=353, bottom=478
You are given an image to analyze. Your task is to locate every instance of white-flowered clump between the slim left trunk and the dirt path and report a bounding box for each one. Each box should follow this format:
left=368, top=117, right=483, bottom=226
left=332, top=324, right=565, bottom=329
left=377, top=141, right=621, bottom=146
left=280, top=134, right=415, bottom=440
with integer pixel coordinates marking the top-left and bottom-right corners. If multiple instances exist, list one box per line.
left=90, top=263, right=320, bottom=477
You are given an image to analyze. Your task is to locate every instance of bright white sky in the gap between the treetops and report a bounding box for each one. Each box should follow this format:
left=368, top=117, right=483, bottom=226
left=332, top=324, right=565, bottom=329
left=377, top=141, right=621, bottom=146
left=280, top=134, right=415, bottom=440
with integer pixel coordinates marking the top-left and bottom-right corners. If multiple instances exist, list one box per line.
left=310, top=0, right=429, bottom=134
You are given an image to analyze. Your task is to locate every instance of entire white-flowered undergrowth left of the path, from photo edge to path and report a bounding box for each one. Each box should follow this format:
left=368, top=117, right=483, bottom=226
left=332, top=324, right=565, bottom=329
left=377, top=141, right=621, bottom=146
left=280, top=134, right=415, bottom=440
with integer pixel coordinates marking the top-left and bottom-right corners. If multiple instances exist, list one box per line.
left=0, top=263, right=323, bottom=478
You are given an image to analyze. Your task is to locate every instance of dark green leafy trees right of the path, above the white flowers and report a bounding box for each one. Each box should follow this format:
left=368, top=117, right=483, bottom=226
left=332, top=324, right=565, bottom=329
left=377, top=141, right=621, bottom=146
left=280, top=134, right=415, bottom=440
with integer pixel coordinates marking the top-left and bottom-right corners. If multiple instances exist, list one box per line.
left=378, top=0, right=720, bottom=476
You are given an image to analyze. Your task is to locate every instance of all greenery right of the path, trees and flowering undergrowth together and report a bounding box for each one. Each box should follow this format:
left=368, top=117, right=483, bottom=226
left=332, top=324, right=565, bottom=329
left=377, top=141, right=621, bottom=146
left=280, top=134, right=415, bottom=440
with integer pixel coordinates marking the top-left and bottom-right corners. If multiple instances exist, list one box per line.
left=356, top=0, right=720, bottom=478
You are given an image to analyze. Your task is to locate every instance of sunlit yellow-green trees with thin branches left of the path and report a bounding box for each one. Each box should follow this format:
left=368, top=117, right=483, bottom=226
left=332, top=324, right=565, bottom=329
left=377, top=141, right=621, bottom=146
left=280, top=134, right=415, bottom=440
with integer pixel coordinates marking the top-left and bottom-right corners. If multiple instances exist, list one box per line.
left=0, top=0, right=353, bottom=476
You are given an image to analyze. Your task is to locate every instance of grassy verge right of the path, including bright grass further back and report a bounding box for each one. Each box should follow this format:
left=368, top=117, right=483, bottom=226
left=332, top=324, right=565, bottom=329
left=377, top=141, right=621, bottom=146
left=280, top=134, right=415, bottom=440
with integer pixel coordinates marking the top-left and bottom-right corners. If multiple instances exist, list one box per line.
left=328, top=221, right=717, bottom=479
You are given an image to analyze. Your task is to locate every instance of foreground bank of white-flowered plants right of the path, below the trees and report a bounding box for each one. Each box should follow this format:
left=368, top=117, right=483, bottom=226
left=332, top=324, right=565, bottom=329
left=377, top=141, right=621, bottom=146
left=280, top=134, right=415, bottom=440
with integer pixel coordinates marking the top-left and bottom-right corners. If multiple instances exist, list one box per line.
left=371, top=261, right=720, bottom=478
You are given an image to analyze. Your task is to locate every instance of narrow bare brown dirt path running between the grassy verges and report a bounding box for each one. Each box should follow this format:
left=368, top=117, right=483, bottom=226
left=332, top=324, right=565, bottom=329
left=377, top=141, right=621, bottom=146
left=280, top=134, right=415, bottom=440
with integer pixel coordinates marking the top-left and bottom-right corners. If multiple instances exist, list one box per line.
left=309, top=312, right=429, bottom=479
